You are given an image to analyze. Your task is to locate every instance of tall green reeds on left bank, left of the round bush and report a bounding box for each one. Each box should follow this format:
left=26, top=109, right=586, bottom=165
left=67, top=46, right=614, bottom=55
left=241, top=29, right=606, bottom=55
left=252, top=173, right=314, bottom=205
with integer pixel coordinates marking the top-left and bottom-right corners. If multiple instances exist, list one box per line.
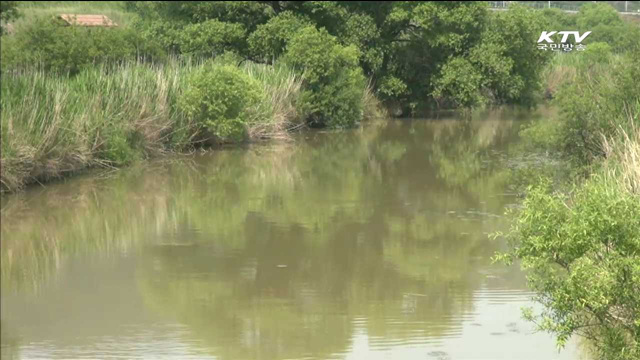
left=0, top=59, right=188, bottom=190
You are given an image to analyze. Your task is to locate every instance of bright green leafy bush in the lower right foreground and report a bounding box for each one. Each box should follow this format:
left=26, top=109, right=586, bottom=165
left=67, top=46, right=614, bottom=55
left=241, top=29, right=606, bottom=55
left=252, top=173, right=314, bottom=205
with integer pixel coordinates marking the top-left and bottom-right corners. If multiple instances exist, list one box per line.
left=499, top=176, right=640, bottom=360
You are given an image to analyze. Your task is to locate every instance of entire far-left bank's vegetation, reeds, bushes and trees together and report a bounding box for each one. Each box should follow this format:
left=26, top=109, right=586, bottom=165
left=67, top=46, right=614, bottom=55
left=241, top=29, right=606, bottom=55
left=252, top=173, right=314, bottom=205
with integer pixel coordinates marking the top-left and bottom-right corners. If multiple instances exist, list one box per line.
left=0, top=2, right=548, bottom=190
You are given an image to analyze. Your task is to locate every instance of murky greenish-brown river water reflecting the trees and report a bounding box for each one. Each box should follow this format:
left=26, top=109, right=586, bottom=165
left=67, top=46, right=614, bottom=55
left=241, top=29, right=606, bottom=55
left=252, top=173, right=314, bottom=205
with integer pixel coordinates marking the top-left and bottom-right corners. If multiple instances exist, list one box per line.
left=1, top=111, right=583, bottom=360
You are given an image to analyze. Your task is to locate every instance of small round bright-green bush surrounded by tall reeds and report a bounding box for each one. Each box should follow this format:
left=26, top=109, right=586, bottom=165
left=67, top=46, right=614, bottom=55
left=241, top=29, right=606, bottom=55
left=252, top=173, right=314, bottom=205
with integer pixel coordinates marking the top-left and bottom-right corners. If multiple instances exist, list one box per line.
left=178, top=62, right=266, bottom=142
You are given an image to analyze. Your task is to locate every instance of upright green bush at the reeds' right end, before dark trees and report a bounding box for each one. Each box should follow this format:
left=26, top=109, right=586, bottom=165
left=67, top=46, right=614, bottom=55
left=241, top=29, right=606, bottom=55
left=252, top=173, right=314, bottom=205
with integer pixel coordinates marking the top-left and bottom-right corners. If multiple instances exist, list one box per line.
left=284, top=27, right=366, bottom=128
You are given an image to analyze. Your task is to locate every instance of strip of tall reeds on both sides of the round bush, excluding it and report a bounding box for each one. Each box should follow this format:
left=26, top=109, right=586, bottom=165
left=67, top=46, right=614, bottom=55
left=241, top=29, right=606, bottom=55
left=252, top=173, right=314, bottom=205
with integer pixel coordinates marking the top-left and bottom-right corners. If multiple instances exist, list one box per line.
left=0, top=60, right=312, bottom=191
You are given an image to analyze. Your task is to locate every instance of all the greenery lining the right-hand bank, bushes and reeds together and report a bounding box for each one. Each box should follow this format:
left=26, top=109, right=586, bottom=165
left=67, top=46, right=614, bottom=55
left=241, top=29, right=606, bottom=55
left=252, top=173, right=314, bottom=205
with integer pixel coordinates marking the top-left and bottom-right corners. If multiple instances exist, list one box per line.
left=498, top=9, right=640, bottom=360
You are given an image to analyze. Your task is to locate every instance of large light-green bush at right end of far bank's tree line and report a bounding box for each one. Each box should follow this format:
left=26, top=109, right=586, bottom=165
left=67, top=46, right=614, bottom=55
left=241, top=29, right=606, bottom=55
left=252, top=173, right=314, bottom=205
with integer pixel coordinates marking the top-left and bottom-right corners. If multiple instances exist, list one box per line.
left=431, top=6, right=548, bottom=107
